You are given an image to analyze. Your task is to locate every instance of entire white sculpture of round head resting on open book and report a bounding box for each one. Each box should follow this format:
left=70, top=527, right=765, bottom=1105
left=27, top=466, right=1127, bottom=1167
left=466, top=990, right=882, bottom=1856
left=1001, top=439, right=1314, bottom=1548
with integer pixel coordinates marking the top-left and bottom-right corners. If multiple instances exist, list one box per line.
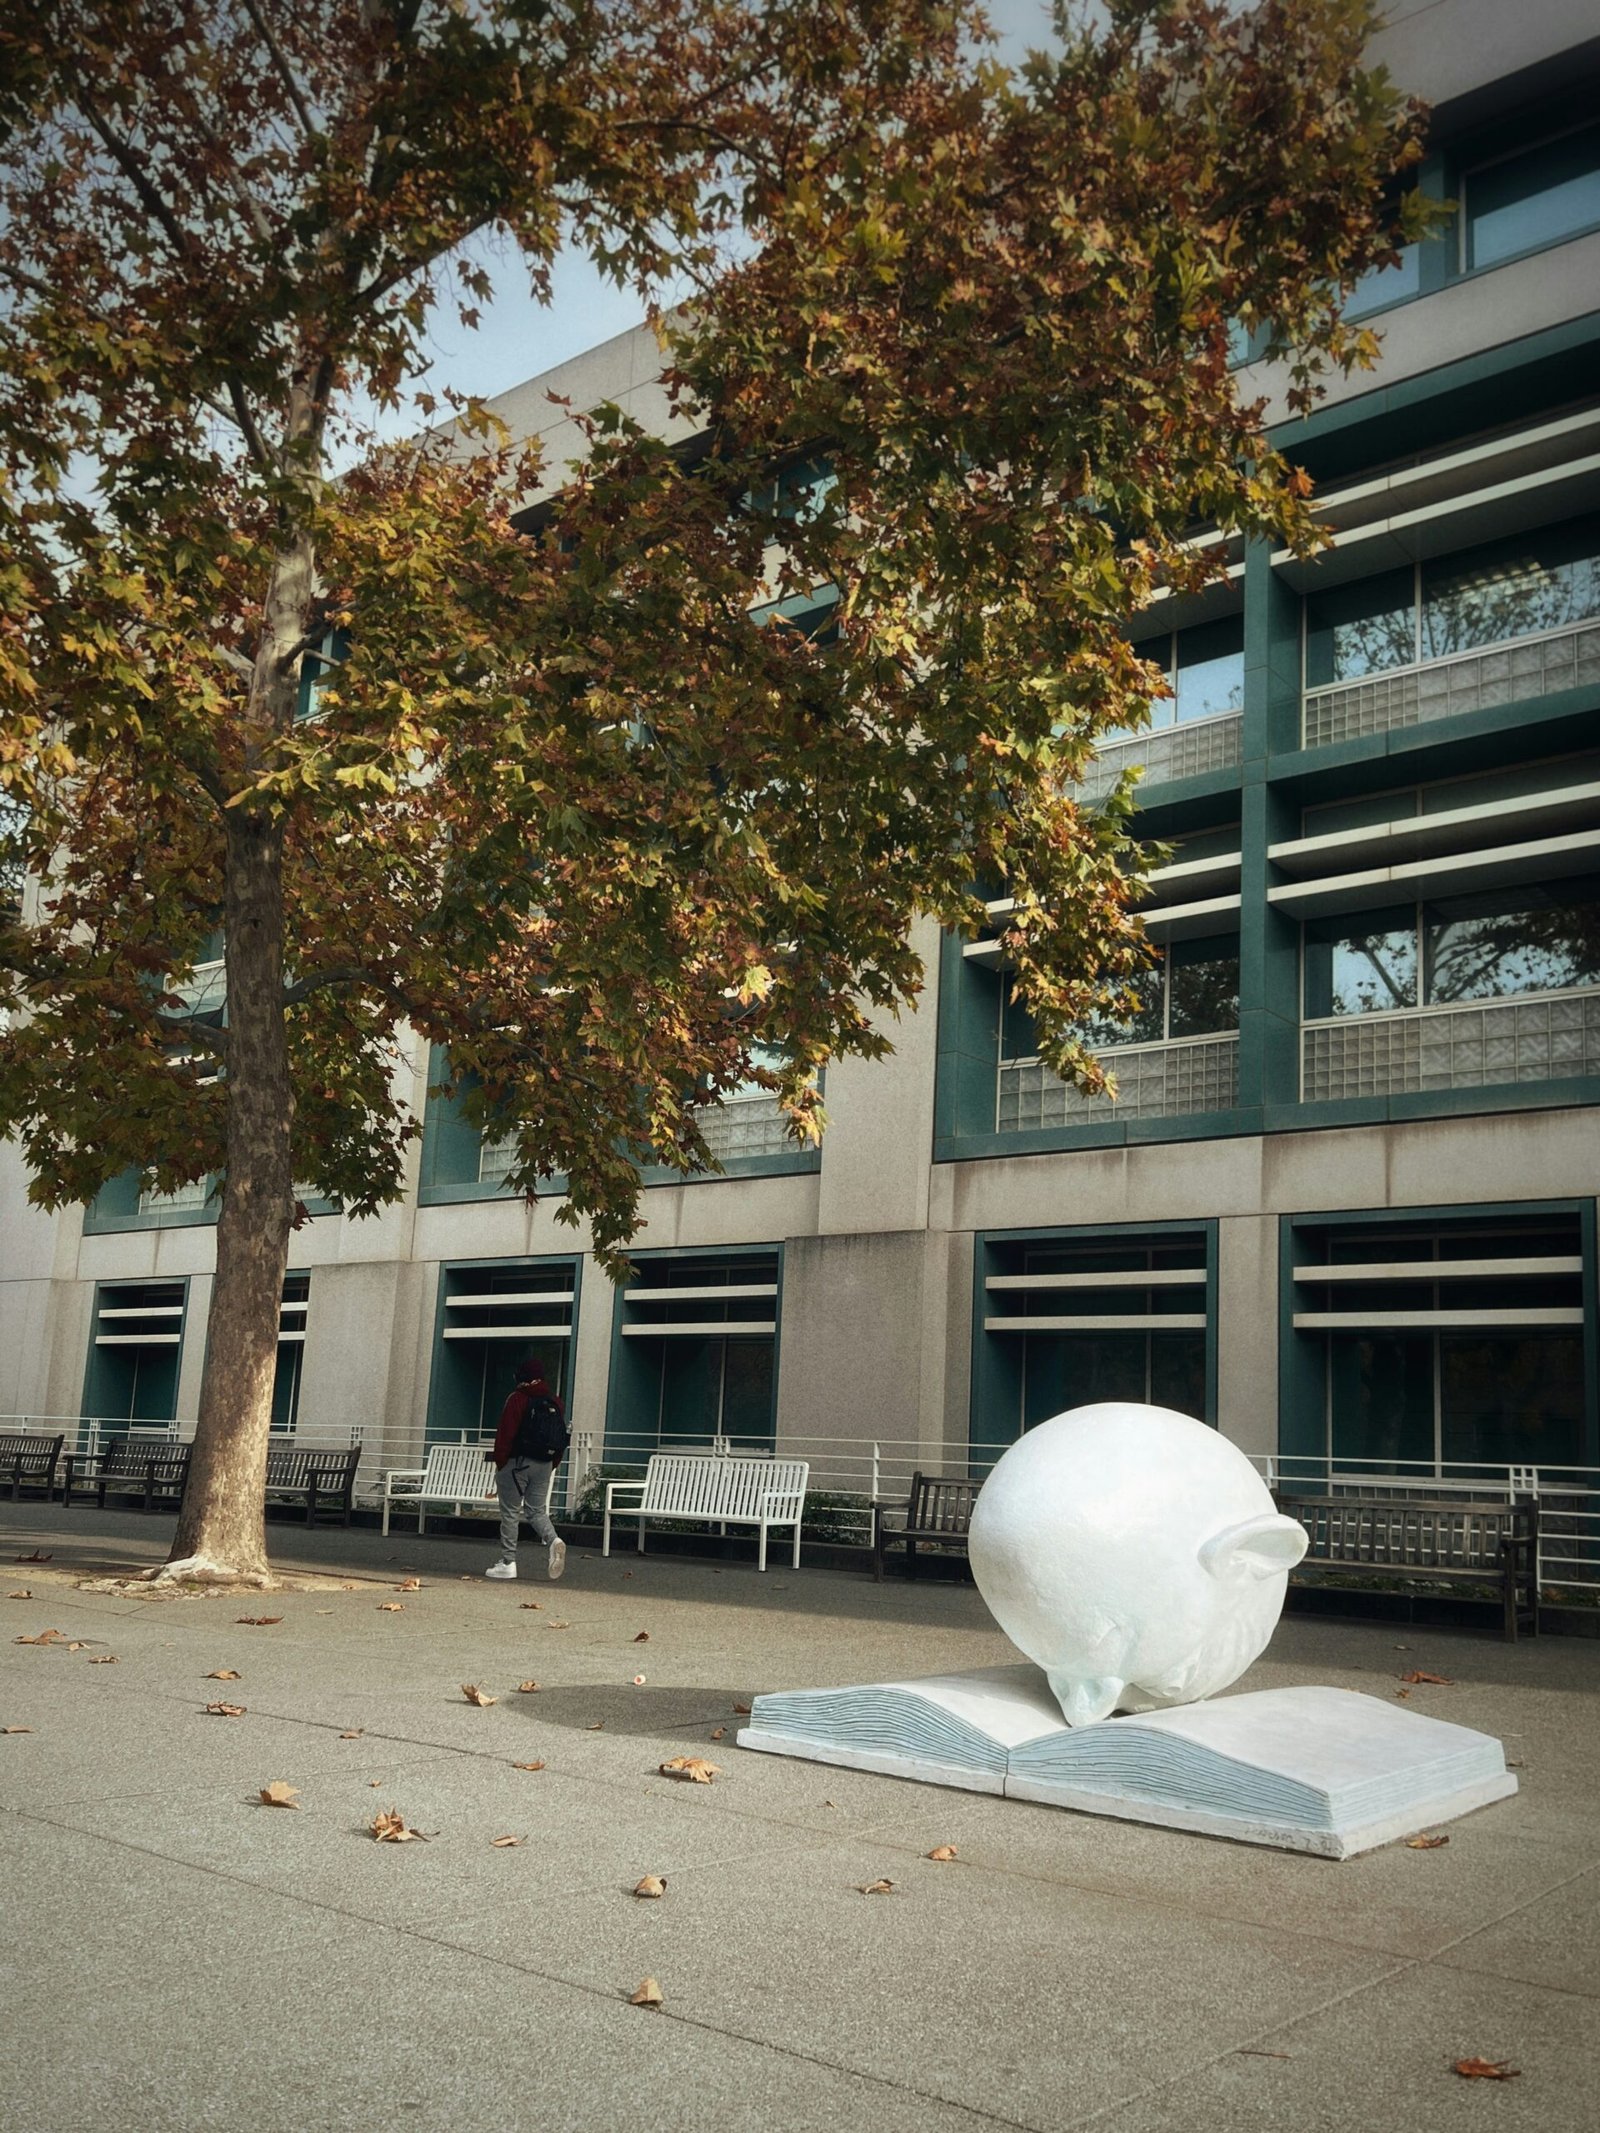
left=738, top=1401, right=1517, bottom=1858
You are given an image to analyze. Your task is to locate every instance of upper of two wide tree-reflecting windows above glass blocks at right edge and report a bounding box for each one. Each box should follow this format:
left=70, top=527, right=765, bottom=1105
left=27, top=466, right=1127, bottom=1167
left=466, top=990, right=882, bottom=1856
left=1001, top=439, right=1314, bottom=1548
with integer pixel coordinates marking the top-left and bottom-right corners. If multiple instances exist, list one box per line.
left=1306, top=514, right=1600, bottom=689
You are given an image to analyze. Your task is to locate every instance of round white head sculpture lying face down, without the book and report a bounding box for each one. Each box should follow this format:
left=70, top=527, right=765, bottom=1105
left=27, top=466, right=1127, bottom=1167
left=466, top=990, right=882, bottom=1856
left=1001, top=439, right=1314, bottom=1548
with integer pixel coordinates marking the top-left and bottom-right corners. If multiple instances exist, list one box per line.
left=969, top=1401, right=1306, bottom=1726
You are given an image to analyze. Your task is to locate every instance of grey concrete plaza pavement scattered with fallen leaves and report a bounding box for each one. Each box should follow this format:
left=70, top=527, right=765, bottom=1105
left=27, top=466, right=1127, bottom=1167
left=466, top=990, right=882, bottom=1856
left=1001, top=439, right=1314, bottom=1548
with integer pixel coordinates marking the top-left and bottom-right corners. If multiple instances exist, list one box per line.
left=0, top=1504, right=1600, bottom=2133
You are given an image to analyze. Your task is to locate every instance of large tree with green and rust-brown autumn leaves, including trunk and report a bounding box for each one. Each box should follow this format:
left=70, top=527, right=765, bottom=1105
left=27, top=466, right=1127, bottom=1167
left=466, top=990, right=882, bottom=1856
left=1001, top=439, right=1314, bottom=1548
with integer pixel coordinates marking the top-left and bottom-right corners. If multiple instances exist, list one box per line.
left=0, top=0, right=1419, bottom=1578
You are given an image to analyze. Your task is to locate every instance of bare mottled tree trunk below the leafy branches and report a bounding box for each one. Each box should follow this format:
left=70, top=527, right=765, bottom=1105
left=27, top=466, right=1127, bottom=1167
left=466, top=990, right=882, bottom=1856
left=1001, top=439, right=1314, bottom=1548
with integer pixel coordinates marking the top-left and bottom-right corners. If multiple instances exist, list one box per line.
left=162, top=808, right=294, bottom=1583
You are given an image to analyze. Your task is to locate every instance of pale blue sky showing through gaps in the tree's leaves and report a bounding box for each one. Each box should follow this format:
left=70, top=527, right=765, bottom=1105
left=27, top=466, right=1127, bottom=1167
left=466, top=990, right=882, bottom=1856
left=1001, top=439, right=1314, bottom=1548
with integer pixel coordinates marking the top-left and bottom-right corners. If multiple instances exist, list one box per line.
left=378, top=0, right=1070, bottom=435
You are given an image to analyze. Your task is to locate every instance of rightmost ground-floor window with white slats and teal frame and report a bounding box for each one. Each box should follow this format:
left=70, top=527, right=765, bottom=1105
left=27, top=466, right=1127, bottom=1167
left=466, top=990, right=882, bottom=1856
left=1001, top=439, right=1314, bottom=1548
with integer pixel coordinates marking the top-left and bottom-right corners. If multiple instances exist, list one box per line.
left=1293, top=1212, right=1585, bottom=1476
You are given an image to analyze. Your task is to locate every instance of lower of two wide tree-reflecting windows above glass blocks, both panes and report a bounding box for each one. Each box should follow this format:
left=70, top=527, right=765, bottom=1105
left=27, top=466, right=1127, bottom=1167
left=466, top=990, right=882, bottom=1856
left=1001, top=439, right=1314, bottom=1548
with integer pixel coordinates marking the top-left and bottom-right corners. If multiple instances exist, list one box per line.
left=1306, top=877, right=1600, bottom=1022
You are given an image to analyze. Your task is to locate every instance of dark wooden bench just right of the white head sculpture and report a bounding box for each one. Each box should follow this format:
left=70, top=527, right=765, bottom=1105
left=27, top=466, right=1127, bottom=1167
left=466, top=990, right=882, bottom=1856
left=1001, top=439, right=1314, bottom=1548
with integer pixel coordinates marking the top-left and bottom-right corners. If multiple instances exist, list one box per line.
left=1276, top=1489, right=1538, bottom=1642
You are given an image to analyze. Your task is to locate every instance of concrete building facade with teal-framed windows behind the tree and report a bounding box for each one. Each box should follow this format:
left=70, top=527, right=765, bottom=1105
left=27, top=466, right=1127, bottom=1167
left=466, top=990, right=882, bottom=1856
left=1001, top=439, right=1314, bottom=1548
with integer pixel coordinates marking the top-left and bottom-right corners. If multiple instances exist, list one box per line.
left=0, top=0, right=1600, bottom=1501
